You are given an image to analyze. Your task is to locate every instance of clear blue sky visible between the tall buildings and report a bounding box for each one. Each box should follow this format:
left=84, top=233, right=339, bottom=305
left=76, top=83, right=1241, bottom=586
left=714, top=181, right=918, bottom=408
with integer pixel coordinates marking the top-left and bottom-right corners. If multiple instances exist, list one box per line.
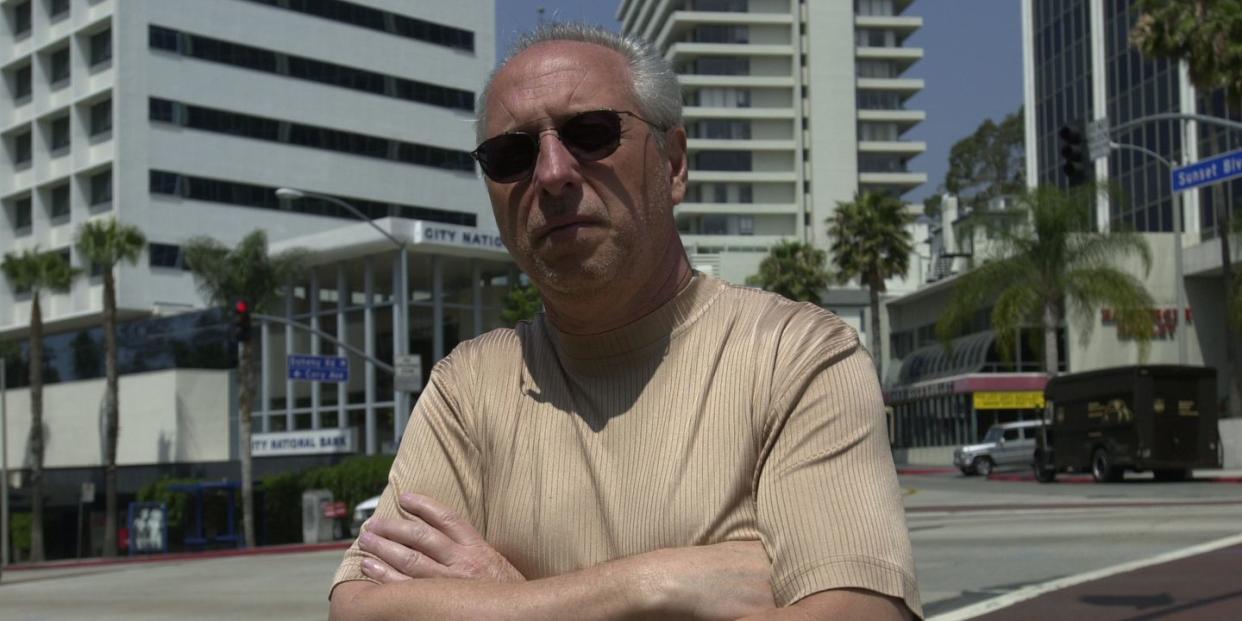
left=496, top=0, right=1022, bottom=202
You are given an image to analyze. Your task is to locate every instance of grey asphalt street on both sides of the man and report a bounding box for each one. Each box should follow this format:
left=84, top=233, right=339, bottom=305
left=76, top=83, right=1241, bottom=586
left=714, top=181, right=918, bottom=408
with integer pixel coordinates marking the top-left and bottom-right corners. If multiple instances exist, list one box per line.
left=0, top=468, right=1242, bottom=621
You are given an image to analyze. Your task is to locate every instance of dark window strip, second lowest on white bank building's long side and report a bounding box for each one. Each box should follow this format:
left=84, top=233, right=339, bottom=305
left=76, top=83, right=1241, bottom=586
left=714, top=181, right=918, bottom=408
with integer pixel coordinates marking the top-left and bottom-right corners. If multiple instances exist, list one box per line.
left=150, top=98, right=474, bottom=173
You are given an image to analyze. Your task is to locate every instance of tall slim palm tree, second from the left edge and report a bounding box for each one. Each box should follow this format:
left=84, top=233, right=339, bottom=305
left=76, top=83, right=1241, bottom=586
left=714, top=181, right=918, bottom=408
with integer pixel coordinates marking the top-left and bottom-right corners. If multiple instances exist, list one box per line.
left=77, top=217, right=147, bottom=558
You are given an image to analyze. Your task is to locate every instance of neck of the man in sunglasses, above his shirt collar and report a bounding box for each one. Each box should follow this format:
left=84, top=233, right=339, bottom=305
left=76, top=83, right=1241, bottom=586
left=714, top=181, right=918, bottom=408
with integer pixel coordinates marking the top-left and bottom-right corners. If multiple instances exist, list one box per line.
left=544, top=240, right=694, bottom=335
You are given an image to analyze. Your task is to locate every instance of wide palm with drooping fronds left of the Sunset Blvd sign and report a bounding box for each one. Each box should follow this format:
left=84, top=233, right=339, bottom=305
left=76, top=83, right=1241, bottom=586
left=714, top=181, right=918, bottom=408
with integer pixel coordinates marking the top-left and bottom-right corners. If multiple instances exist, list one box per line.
left=936, top=185, right=1155, bottom=375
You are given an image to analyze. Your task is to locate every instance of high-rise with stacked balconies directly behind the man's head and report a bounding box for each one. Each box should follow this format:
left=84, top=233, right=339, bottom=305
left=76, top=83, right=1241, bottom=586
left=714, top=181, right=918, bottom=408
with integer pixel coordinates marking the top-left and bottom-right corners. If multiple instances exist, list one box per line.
left=617, top=0, right=927, bottom=282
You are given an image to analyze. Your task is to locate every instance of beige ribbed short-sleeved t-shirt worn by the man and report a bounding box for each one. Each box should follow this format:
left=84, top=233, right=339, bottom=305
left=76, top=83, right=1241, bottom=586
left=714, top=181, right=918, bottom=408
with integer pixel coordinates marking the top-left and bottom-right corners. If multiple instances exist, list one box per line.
left=334, top=274, right=922, bottom=615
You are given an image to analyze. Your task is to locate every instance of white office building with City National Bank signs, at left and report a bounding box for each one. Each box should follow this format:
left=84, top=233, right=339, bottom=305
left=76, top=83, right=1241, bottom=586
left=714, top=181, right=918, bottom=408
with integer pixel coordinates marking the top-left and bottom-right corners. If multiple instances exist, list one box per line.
left=0, top=0, right=512, bottom=556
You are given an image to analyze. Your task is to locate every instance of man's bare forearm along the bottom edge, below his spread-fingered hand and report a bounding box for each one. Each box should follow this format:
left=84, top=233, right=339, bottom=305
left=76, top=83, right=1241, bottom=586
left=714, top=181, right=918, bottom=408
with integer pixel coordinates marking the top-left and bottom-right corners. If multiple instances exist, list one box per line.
left=330, top=559, right=661, bottom=621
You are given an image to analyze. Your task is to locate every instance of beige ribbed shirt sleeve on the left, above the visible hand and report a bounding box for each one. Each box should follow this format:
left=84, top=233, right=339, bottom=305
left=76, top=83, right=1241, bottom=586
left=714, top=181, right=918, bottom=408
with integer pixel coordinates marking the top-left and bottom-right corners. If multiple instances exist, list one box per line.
left=329, top=351, right=482, bottom=596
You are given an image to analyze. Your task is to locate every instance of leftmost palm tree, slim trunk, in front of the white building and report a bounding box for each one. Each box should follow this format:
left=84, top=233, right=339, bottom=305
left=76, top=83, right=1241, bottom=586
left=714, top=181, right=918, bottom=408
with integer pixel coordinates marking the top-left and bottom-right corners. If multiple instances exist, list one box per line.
left=0, top=248, right=81, bottom=563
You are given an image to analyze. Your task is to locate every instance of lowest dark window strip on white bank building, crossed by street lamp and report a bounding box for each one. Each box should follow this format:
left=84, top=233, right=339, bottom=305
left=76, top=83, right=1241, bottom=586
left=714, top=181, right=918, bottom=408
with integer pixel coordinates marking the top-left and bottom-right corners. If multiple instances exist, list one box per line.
left=150, top=170, right=478, bottom=226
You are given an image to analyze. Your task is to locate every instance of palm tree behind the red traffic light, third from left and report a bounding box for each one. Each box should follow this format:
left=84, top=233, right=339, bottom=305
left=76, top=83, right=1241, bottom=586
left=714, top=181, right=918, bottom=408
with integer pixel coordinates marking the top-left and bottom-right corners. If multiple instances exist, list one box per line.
left=183, top=230, right=308, bottom=548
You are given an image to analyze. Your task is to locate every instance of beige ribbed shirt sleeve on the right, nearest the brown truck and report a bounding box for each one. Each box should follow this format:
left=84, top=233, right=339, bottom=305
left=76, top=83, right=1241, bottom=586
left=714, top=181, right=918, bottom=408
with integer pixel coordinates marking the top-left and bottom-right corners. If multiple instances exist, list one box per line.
left=755, top=330, right=922, bottom=616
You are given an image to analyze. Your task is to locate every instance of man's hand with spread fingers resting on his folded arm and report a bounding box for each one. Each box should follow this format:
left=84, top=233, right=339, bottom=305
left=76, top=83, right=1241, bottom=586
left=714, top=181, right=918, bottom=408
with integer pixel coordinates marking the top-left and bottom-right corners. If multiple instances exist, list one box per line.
left=358, top=493, right=525, bottom=584
